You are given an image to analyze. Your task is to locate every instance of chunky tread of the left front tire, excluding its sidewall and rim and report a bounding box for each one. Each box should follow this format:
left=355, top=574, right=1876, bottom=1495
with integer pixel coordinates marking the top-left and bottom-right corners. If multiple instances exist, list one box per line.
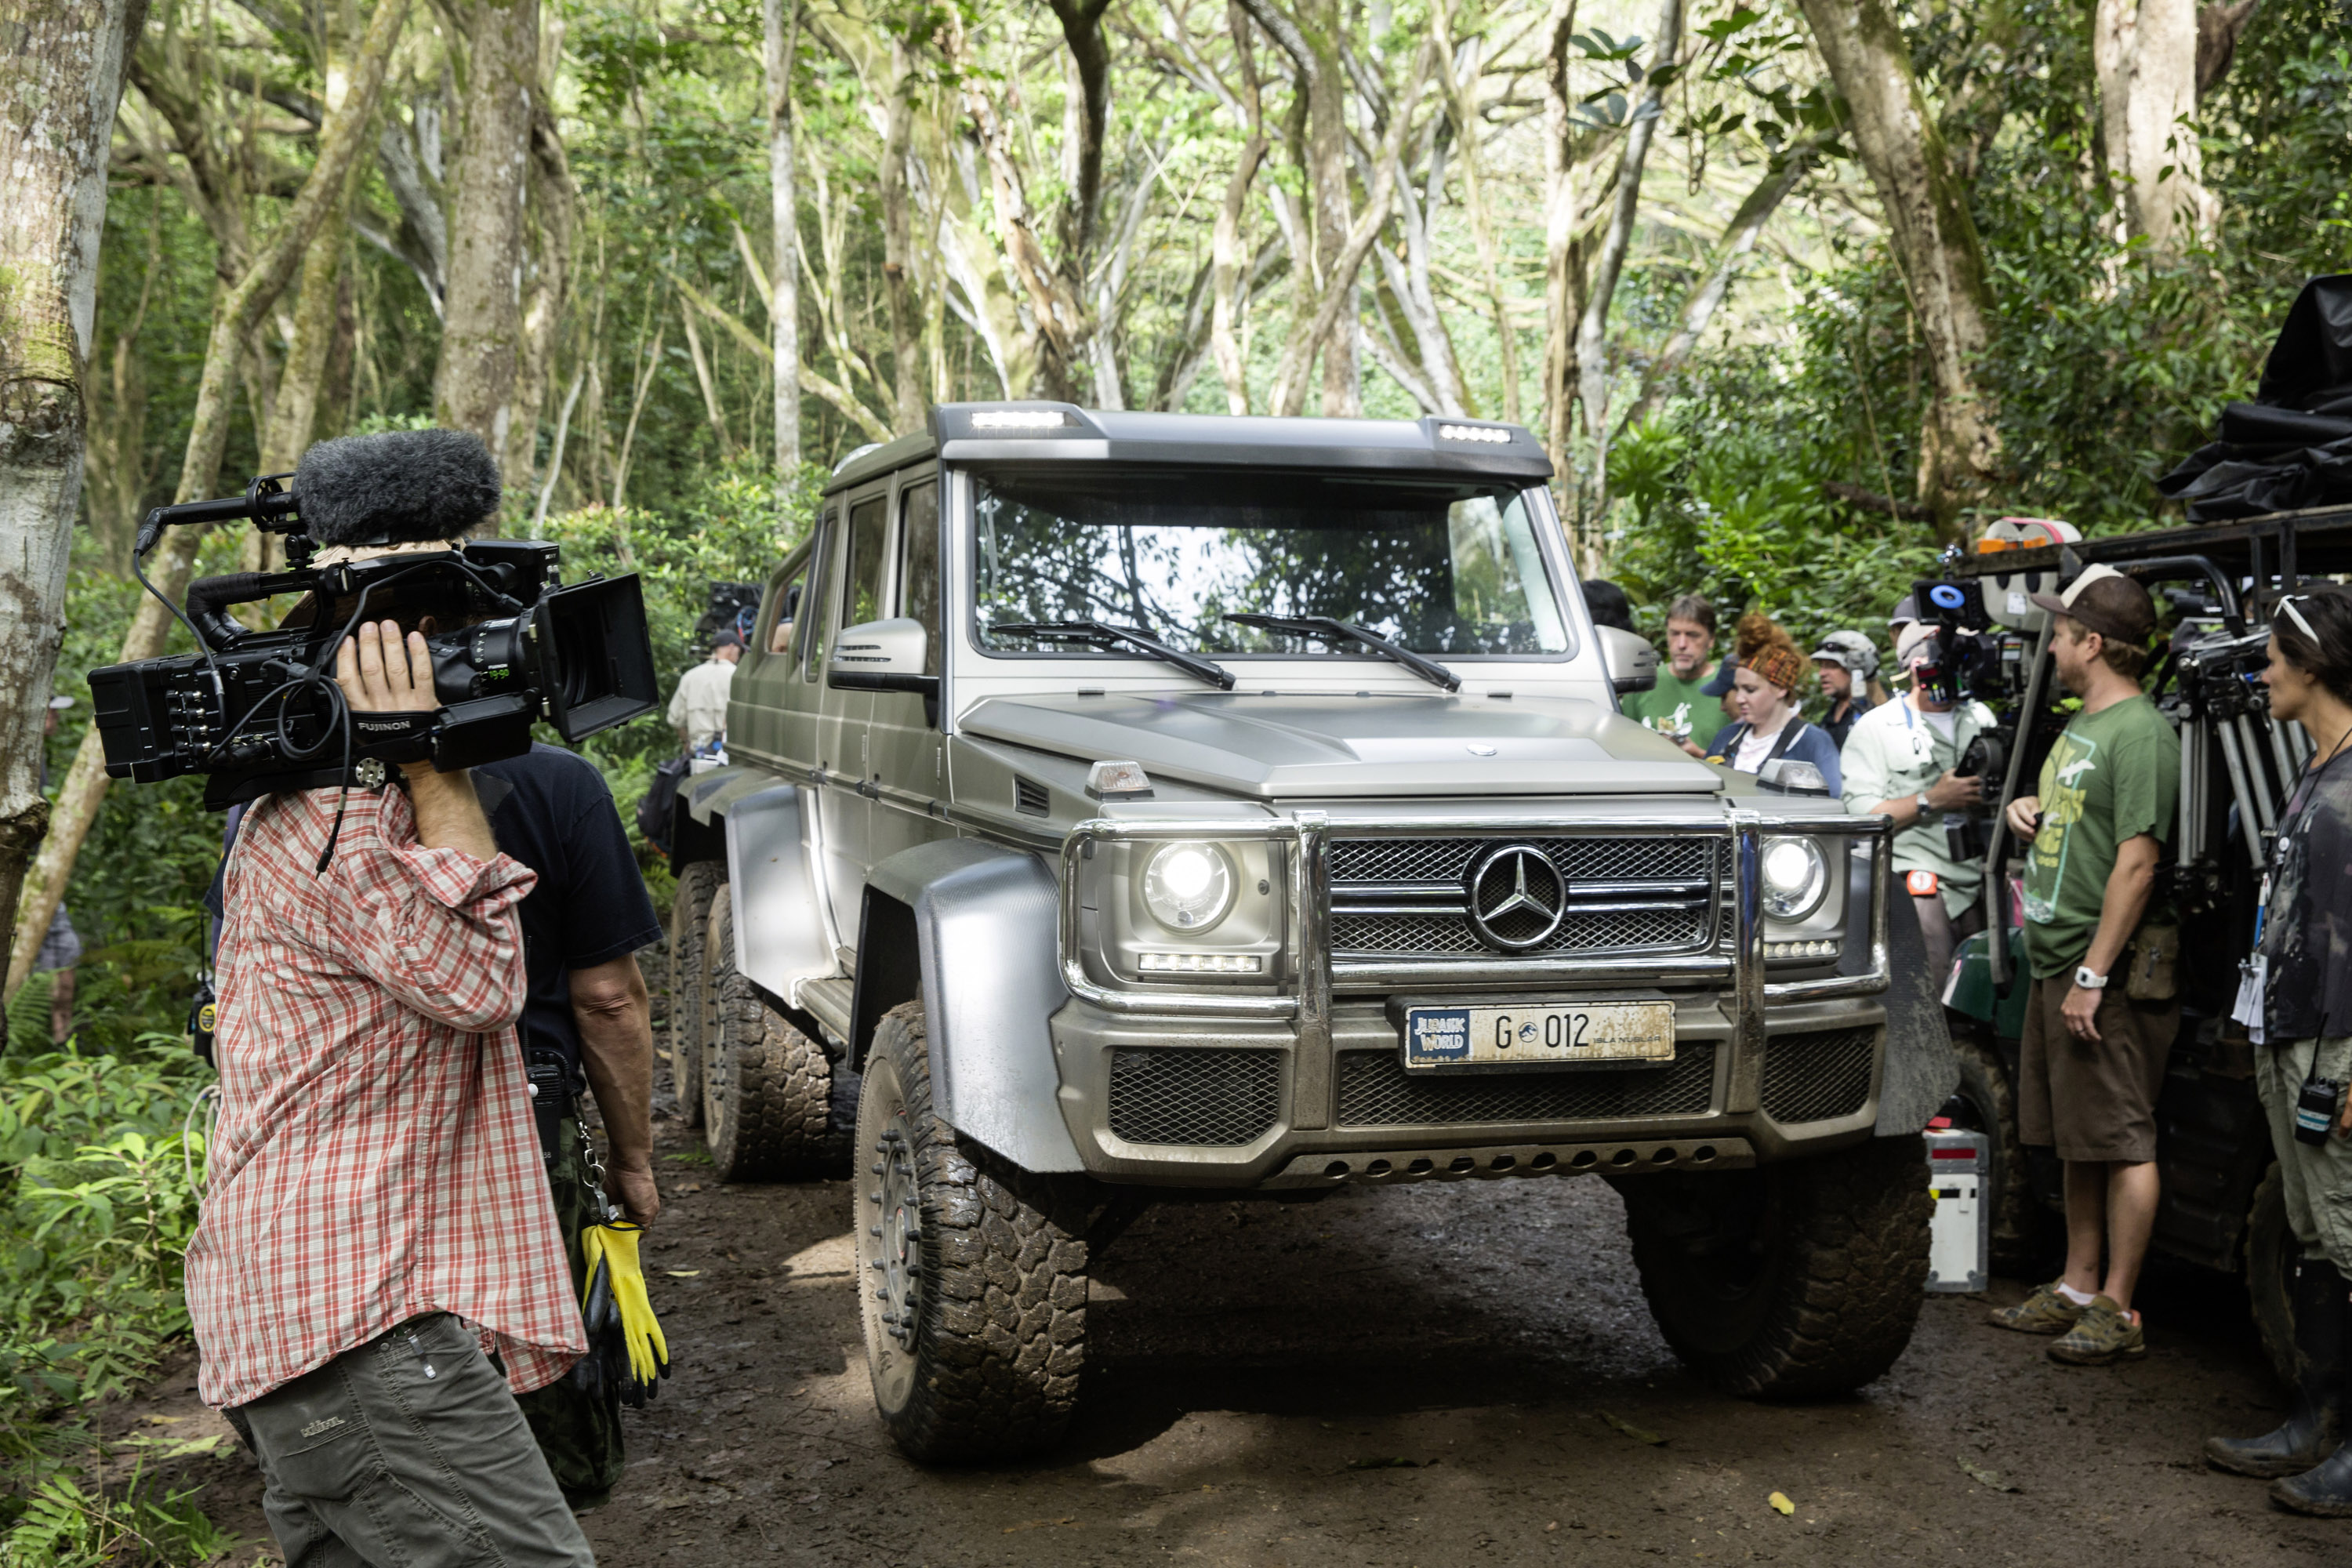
left=858, top=1001, right=1091, bottom=1462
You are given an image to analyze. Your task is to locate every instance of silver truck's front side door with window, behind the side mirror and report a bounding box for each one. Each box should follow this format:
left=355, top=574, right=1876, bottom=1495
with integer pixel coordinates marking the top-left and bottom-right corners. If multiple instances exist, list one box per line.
left=868, top=473, right=948, bottom=867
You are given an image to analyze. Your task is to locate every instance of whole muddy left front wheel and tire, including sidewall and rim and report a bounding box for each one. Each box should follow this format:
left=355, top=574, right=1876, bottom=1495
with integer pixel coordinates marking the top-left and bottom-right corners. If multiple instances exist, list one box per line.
left=851, top=1001, right=1089, bottom=1462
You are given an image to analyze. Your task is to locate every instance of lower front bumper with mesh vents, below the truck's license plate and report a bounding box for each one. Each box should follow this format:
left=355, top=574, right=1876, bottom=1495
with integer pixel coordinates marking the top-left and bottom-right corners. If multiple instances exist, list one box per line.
left=1054, top=994, right=1886, bottom=1187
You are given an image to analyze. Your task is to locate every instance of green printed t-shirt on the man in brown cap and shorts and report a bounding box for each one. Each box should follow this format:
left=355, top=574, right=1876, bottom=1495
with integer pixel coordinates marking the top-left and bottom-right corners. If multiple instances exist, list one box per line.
left=2025, top=696, right=2180, bottom=980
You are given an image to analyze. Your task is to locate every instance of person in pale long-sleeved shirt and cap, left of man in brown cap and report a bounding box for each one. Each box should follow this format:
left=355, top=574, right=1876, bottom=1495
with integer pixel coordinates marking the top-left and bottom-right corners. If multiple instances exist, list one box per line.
left=1837, top=623, right=1992, bottom=989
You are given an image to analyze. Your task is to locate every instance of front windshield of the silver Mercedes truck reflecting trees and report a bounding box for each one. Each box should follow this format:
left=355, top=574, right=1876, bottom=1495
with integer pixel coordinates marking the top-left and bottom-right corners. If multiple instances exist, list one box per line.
left=974, top=473, right=1569, bottom=659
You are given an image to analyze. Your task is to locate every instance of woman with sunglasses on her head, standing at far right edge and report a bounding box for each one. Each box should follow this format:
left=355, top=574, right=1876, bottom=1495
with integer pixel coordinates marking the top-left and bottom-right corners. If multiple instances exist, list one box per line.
left=2206, top=590, right=2352, bottom=1516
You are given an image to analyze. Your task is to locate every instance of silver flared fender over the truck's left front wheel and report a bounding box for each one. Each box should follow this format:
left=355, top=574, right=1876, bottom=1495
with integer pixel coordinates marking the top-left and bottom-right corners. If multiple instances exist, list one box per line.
left=854, top=839, right=1084, bottom=1171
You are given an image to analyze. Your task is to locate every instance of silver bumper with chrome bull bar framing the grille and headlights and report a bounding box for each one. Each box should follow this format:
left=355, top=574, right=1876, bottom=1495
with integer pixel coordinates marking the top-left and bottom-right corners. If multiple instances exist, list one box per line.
left=1051, top=808, right=1889, bottom=1189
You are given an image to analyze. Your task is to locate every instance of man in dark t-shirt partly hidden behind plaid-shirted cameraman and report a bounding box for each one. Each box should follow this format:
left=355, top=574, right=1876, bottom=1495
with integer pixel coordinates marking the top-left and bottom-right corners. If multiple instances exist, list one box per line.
left=473, top=746, right=661, bottom=1509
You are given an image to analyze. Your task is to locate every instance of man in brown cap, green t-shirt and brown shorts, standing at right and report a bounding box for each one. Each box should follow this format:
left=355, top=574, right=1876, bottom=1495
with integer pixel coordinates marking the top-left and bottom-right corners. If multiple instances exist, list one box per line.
left=1992, top=567, right=2180, bottom=1366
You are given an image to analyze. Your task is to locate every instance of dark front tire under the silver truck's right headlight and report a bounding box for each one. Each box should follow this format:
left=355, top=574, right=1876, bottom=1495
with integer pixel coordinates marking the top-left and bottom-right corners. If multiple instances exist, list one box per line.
left=1628, top=1138, right=1936, bottom=1399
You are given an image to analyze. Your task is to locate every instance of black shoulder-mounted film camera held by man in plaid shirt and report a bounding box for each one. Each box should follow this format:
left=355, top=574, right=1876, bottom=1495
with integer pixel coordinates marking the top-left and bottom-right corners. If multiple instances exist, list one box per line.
left=89, top=475, right=656, bottom=808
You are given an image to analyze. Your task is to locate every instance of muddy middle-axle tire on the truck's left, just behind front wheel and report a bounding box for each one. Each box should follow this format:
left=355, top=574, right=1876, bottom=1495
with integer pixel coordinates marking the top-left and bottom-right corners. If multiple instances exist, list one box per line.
left=703, top=884, right=844, bottom=1182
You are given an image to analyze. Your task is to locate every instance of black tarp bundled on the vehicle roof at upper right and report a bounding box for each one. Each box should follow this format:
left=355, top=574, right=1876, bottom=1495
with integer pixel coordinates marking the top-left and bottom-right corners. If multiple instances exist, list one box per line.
left=2157, top=273, right=2352, bottom=522
